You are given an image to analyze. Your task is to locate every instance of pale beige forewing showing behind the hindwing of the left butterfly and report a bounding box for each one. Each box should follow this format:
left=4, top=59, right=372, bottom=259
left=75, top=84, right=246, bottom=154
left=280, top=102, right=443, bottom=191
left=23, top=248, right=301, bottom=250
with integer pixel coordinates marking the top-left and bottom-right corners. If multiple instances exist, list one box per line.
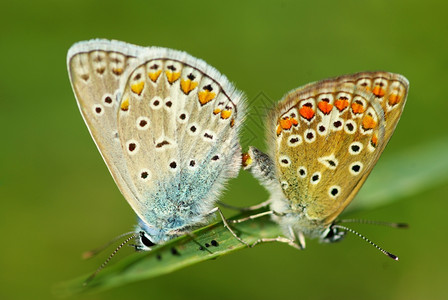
left=67, top=40, right=145, bottom=214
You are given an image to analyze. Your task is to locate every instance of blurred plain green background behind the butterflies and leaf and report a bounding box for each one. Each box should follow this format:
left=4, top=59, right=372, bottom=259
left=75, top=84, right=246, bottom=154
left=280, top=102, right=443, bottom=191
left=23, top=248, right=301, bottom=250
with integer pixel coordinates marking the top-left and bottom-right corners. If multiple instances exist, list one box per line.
left=0, top=0, right=448, bottom=299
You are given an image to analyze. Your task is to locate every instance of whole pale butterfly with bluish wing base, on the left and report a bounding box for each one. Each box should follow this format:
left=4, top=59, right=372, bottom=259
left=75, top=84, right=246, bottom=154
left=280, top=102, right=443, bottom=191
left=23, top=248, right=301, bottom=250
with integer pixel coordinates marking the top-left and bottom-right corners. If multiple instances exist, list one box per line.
left=67, top=39, right=245, bottom=250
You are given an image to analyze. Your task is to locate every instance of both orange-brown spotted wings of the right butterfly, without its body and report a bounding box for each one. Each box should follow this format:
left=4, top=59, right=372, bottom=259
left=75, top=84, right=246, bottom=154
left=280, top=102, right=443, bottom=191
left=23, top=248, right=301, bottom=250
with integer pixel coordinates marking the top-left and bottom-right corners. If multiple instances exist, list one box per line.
left=270, top=72, right=408, bottom=224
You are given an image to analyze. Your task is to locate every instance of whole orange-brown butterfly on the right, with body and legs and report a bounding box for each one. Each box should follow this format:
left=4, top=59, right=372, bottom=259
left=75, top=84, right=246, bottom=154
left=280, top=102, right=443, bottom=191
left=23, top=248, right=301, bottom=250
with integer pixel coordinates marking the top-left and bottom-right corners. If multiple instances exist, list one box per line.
left=243, top=72, right=409, bottom=259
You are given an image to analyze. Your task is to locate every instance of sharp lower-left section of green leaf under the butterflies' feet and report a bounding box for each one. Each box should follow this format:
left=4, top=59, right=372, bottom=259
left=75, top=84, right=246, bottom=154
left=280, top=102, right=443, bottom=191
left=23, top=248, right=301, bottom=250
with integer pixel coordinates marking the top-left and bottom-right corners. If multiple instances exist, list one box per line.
left=55, top=211, right=281, bottom=297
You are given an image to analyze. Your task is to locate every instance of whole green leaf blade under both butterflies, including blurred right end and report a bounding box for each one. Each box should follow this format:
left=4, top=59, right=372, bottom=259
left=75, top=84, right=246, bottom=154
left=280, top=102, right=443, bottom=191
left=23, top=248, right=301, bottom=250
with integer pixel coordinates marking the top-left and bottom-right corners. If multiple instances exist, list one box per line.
left=55, top=139, right=448, bottom=296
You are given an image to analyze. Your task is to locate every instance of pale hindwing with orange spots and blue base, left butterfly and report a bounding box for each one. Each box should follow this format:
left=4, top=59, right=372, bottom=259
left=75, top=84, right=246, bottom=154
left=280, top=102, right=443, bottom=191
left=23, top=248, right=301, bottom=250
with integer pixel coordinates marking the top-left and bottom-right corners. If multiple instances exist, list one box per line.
left=118, top=48, right=244, bottom=231
